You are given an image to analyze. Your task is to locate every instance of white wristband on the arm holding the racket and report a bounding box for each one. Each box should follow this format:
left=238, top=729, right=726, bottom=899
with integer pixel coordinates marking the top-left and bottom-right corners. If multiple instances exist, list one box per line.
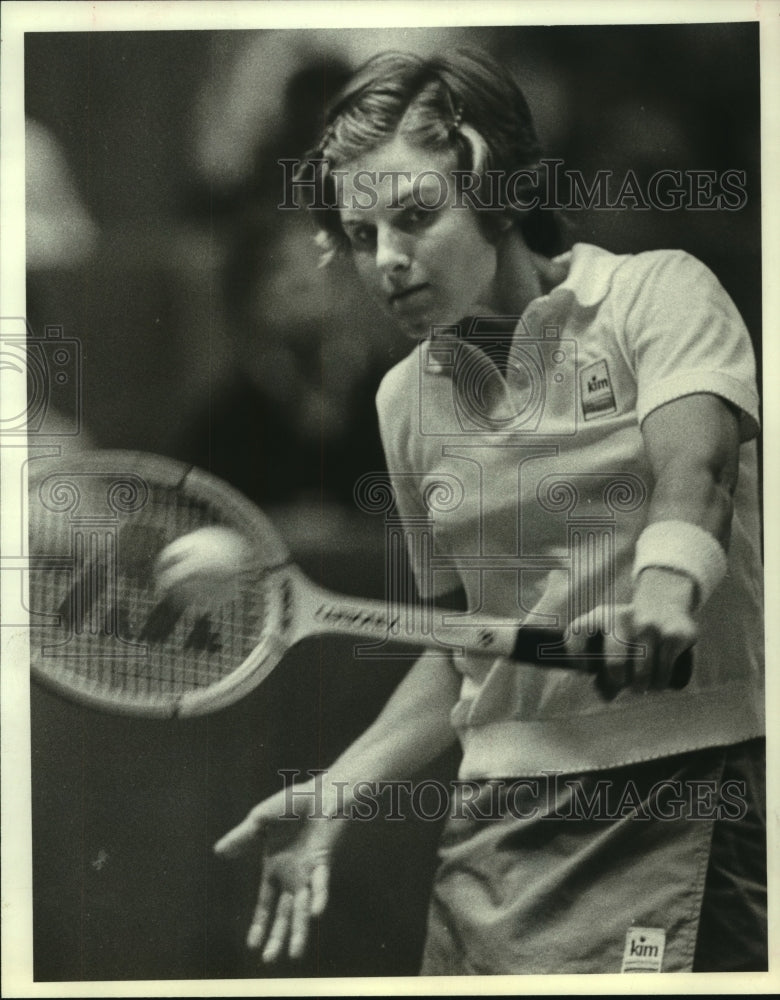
left=633, top=521, right=728, bottom=607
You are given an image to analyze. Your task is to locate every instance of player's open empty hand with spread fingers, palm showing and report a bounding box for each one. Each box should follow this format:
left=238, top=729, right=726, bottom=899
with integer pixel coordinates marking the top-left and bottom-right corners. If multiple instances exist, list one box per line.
left=214, top=782, right=343, bottom=962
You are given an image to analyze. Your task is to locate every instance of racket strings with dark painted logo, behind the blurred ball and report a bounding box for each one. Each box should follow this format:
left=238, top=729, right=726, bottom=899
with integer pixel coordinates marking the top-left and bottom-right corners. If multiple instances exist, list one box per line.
left=29, top=486, right=272, bottom=702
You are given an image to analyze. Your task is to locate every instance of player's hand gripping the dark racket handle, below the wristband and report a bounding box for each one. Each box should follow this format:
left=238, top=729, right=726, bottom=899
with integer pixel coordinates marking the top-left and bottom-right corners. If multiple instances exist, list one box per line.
left=569, top=567, right=698, bottom=700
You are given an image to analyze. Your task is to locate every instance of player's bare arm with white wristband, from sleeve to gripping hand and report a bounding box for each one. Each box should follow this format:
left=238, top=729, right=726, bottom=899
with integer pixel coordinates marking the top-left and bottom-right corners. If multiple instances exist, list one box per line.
left=605, top=393, right=739, bottom=690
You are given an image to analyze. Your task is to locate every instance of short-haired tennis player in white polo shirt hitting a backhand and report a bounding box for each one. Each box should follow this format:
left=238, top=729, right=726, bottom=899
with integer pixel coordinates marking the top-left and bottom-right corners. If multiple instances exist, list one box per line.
left=209, top=52, right=767, bottom=975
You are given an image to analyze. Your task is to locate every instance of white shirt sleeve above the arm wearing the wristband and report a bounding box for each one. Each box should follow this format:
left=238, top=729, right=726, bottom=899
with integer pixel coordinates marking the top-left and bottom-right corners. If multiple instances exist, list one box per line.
left=623, top=251, right=759, bottom=441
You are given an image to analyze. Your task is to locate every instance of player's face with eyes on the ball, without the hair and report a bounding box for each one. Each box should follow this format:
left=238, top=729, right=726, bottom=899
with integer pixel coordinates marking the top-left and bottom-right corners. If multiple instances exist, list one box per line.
left=340, top=136, right=497, bottom=338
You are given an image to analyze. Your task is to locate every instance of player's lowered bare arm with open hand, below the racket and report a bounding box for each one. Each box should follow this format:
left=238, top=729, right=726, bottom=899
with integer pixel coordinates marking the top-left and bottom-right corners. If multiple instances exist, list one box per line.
left=215, top=632, right=459, bottom=962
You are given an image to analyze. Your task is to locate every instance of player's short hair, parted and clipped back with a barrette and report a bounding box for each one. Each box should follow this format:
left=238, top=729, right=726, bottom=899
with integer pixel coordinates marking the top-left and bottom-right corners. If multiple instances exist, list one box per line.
left=306, top=49, right=566, bottom=261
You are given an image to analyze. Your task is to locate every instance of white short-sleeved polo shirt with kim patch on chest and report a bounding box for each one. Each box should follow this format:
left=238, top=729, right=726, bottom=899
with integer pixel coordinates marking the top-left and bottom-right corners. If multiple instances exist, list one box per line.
left=377, top=244, right=764, bottom=778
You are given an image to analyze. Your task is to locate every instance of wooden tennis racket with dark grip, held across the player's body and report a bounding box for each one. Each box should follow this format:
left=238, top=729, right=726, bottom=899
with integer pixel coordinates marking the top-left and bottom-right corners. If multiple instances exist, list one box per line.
left=29, top=451, right=581, bottom=717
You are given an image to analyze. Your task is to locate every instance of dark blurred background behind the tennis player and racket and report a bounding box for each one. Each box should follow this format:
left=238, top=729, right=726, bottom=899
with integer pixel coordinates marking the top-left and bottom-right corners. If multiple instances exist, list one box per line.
left=25, top=24, right=761, bottom=980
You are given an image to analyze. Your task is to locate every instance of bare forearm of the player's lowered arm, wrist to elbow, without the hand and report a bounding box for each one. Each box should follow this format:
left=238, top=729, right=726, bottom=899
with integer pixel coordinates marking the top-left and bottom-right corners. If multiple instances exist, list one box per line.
left=316, top=655, right=460, bottom=814
